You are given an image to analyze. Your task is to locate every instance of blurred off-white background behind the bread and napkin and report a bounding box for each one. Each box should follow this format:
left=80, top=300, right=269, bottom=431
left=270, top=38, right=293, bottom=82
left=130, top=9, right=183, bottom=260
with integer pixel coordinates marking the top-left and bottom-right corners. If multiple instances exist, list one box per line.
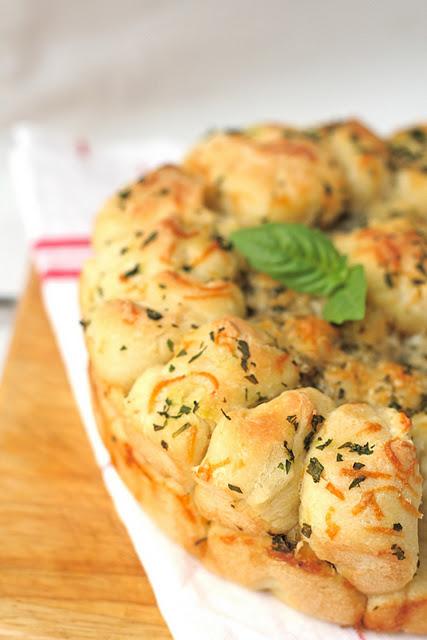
left=0, top=0, right=427, bottom=362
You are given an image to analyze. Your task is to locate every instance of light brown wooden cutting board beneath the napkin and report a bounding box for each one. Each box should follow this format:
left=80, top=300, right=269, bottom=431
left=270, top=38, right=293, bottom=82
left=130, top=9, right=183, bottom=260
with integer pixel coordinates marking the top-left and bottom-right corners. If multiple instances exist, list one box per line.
left=0, top=274, right=171, bottom=640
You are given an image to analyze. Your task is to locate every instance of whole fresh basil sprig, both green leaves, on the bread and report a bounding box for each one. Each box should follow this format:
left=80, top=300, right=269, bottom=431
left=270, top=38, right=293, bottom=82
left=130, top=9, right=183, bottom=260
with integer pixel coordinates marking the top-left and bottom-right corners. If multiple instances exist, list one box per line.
left=230, top=223, right=367, bottom=324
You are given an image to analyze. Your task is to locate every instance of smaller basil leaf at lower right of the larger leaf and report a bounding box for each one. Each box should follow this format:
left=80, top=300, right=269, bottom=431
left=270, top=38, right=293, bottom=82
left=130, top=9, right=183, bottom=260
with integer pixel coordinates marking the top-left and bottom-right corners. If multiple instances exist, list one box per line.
left=323, top=264, right=367, bottom=324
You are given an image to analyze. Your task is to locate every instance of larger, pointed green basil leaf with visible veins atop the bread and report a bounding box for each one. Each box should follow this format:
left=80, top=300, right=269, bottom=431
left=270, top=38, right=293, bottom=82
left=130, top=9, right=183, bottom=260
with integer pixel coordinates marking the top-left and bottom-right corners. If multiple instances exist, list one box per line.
left=230, top=223, right=349, bottom=296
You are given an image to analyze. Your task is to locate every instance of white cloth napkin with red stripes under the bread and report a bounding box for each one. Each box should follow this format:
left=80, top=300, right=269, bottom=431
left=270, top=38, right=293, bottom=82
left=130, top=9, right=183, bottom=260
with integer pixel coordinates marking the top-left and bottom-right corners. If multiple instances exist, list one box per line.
left=10, top=126, right=415, bottom=640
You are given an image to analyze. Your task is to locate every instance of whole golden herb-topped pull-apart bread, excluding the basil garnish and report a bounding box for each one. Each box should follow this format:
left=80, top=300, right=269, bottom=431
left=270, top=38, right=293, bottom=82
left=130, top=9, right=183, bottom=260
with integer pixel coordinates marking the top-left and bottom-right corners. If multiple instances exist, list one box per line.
left=81, top=121, right=427, bottom=633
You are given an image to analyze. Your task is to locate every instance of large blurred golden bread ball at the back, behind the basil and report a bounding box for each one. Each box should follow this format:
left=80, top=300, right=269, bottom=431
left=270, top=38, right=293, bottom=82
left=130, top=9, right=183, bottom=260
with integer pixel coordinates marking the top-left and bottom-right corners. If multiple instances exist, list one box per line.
left=185, top=126, right=345, bottom=230
